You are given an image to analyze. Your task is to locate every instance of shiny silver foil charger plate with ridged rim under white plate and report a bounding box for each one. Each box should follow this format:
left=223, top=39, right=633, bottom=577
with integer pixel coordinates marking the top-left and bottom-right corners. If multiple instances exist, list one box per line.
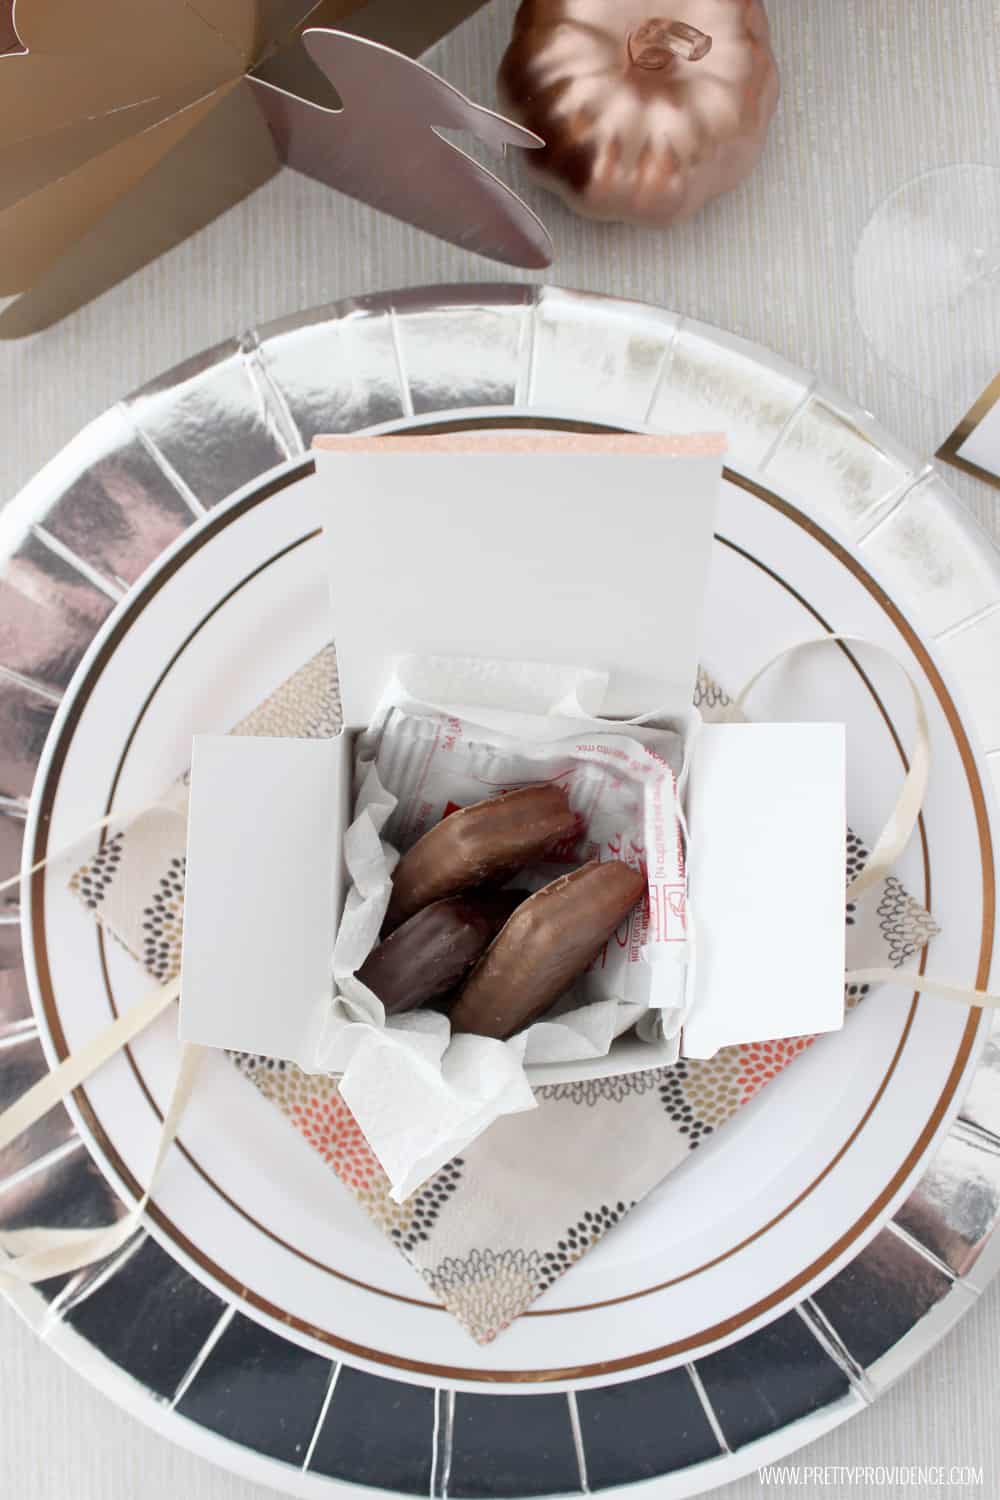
left=0, top=287, right=1000, bottom=1497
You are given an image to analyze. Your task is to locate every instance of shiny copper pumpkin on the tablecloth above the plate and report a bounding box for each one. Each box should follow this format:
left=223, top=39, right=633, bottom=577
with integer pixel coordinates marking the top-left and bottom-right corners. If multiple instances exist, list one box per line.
left=498, top=0, right=778, bottom=225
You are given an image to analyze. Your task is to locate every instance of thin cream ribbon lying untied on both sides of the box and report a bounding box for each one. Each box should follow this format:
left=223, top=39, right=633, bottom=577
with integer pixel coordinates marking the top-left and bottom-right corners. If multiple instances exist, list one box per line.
left=0, top=635, right=1000, bottom=1289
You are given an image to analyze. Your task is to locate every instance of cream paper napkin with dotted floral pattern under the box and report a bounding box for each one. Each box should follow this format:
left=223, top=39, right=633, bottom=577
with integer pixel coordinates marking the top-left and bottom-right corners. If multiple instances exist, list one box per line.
left=70, top=647, right=937, bottom=1344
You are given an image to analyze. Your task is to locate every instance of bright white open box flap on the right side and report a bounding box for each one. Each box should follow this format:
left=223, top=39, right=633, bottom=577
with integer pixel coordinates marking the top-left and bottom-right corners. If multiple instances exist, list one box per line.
left=681, top=723, right=847, bottom=1058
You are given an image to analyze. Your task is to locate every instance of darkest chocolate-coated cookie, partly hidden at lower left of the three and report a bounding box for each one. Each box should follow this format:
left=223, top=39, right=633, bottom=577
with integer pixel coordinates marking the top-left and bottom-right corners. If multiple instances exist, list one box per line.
left=358, top=891, right=525, bottom=1016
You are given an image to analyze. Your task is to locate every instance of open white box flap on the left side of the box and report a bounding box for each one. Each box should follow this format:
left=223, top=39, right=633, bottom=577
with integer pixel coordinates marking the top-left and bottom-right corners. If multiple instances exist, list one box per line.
left=180, top=735, right=351, bottom=1068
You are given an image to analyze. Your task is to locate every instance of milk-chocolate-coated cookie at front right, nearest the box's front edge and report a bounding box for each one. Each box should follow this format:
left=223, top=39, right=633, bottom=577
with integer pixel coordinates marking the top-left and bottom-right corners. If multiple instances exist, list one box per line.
left=450, top=860, right=646, bottom=1041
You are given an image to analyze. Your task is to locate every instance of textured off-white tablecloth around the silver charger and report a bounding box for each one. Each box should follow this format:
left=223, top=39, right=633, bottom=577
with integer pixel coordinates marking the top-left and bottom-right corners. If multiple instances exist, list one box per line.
left=0, top=0, right=1000, bottom=1500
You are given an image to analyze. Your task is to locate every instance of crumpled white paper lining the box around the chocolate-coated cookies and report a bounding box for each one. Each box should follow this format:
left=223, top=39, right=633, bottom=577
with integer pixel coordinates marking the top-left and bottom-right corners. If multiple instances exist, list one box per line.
left=315, top=659, right=687, bottom=1202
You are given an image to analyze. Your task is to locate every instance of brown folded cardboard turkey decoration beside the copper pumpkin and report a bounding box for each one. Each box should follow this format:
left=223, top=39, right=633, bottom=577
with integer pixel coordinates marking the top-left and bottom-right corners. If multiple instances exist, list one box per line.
left=0, top=0, right=552, bottom=297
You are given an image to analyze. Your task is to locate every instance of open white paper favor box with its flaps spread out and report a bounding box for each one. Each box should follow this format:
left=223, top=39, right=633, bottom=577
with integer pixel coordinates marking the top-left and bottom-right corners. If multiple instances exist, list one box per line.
left=181, top=432, right=846, bottom=1085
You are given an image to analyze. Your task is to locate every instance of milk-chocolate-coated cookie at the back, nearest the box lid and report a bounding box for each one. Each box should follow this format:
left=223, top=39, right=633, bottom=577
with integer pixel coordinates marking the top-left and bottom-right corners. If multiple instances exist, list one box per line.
left=384, top=786, right=576, bottom=933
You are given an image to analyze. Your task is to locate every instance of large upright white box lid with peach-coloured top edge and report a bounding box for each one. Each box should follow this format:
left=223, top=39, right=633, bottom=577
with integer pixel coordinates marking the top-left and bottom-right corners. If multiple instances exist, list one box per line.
left=316, top=432, right=724, bottom=726
